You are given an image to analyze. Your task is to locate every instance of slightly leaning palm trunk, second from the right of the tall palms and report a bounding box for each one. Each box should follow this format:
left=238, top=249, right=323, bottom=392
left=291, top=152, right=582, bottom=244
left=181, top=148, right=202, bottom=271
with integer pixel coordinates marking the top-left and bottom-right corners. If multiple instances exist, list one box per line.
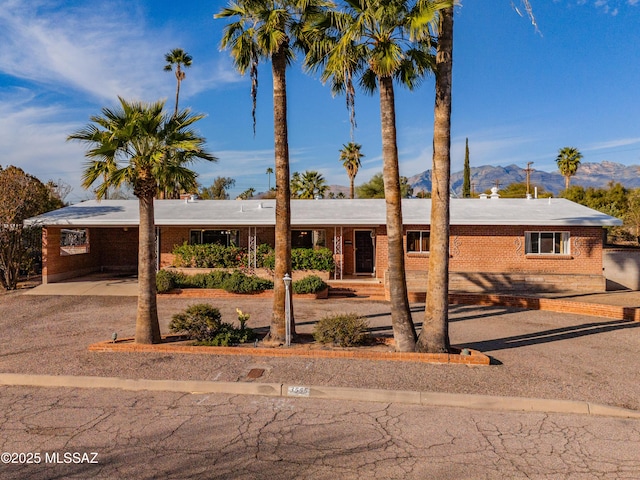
left=380, top=77, right=416, bottom=352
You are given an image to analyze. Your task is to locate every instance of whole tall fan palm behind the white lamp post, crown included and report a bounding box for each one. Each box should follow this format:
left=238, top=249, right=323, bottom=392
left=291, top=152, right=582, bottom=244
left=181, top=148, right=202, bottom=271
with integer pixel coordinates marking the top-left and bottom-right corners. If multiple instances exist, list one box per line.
left=214, top=0, right=329, bottom=344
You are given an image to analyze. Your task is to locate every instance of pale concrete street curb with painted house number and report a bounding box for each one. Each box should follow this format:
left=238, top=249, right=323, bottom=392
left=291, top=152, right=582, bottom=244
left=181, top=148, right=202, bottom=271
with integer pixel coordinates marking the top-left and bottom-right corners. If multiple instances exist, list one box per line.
left=0, top=373, right=640, bottom=420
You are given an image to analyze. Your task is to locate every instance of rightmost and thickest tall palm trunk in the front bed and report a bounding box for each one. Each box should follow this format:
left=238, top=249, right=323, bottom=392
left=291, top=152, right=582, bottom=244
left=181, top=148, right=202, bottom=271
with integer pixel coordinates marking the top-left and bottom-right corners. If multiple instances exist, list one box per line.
left=416, top=7, right=453, bottom=353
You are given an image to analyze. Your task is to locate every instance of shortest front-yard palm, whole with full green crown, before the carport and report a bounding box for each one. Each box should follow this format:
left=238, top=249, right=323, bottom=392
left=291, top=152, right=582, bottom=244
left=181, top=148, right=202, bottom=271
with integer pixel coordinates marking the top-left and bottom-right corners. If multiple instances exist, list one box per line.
left=68, top=98, right=217, bottom=343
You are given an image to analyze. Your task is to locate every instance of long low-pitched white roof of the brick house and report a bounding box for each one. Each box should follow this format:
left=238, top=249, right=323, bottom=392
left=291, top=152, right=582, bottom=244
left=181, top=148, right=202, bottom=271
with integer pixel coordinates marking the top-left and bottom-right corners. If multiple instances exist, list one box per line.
left=25, top=198, right=622, bottom=227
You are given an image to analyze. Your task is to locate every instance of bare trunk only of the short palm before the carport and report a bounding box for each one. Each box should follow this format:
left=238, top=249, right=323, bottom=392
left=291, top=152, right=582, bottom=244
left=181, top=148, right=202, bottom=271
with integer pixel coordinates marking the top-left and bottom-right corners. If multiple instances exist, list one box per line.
left=136, top=189, right=161, bottom=343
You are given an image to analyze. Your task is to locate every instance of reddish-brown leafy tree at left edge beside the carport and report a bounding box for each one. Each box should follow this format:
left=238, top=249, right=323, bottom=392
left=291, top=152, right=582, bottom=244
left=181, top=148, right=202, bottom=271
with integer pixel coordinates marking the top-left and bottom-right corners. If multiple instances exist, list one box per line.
left=0, top=166, right=63, bottom=290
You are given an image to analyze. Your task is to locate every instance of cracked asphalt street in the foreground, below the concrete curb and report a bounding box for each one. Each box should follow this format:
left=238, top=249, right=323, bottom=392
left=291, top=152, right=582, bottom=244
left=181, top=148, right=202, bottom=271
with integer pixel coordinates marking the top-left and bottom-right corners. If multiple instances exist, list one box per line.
left=0, top=387, right=640, bottom=480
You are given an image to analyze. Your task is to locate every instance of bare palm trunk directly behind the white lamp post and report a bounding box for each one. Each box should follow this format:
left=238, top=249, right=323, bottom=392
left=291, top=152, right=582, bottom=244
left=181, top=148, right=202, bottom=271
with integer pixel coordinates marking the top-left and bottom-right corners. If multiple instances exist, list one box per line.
left=265, top=44, right=295, bottom=343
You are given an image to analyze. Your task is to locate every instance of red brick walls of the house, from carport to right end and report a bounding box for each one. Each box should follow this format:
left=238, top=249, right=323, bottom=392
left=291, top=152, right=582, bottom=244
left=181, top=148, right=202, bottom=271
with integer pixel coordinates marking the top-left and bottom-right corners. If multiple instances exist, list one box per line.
left=38, top=221, right=604, bottom=290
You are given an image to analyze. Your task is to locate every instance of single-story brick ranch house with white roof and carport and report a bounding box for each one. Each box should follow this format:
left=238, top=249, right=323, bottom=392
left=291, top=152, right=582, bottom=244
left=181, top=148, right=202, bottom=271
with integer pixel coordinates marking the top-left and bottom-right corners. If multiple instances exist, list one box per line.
left=27, top=198, right=622, bottom=291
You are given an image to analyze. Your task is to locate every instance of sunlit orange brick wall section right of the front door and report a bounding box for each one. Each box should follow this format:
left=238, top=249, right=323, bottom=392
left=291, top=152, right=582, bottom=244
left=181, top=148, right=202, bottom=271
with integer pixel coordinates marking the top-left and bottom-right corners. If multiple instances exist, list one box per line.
left=376, top=225, right=605, bottom=292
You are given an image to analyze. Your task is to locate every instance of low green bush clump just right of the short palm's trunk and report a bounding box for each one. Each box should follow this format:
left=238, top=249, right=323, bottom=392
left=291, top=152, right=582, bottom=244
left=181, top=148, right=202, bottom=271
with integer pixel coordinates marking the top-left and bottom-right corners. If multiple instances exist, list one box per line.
left=169, top=303, right=256, bottom=346
